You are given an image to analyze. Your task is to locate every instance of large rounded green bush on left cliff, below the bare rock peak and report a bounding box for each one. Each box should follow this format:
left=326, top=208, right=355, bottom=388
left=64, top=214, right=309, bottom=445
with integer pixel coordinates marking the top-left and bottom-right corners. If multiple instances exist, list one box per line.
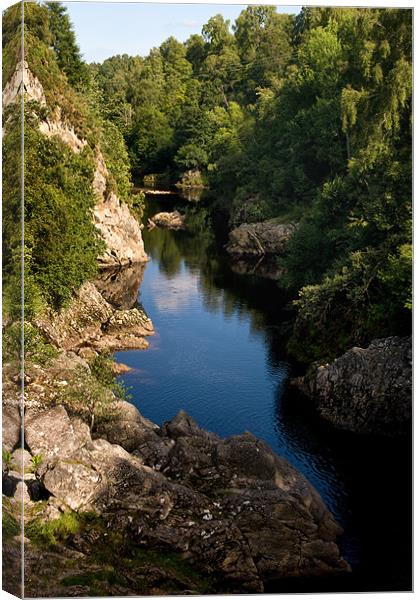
left=25, top=123, right=103, bottom=312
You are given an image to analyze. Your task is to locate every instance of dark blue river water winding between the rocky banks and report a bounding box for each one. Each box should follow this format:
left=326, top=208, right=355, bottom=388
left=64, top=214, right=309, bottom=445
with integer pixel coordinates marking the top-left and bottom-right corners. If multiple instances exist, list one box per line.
left=116, top=196, right=411, bottom=591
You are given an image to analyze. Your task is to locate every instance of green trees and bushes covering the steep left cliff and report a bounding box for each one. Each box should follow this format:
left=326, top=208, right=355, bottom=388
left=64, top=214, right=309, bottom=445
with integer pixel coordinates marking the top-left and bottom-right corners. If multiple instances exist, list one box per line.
left=3, top=2, right=139, bottom=319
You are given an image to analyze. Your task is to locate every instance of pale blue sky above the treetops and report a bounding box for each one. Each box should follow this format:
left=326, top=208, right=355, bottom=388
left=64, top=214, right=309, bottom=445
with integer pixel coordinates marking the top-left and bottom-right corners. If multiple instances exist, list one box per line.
left=63, top=2, right=300, bottom=62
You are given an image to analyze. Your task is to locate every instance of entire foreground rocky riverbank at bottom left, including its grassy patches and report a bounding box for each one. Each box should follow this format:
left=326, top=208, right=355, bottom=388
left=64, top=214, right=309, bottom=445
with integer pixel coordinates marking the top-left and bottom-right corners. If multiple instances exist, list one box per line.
left=3, top=351, right=349, bottom=596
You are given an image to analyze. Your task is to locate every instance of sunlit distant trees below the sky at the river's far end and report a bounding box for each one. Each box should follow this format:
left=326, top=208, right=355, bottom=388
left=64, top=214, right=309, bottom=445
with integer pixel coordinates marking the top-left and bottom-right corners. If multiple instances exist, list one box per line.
left=92, top=6, right=292, bottom=180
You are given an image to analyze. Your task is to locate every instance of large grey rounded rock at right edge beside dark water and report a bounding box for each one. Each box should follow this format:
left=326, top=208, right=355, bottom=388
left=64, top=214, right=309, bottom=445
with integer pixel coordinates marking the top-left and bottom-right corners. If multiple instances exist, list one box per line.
left=292, top=337, right=412, bottom=436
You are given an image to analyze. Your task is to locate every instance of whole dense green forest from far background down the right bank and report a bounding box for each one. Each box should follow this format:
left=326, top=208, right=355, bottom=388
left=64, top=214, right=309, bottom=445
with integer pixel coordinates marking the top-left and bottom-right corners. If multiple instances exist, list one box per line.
left=92, top=6, right=412, bottom=359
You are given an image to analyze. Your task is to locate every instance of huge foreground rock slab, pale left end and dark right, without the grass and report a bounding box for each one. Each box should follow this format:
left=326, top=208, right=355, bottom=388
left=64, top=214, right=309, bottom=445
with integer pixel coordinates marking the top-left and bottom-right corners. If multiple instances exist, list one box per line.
left=21, top=406, right=349, bottom=592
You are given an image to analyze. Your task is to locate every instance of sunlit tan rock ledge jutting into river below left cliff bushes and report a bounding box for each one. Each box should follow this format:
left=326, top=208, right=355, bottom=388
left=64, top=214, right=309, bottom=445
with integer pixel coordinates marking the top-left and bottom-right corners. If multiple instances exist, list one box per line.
left=35, top=282, right=154, bottom=352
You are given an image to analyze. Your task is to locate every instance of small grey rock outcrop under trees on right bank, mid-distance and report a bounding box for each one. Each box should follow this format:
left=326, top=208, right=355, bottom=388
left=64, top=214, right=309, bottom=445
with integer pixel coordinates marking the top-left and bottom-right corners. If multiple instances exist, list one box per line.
left=226, top=221, right=296, bottom=257
